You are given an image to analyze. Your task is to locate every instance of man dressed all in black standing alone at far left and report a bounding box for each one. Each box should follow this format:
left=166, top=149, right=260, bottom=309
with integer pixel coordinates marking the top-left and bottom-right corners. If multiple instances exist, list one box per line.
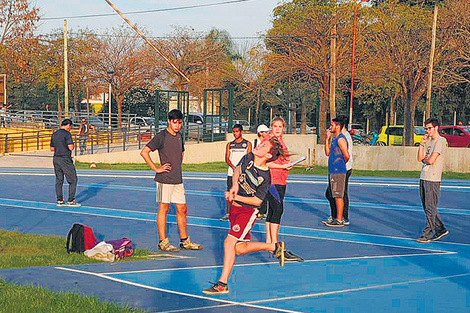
left=51, top=119, right=80, bottom=207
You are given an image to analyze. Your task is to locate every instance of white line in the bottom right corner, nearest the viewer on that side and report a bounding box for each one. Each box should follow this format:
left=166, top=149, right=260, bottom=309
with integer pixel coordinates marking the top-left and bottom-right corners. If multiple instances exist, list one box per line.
left=246, top=273, right=470, bottom=304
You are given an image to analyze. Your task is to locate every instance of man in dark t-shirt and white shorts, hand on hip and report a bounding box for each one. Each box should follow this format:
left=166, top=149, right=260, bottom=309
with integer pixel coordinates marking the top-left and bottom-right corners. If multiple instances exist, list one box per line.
left=140, top=109, right=202, bottom=252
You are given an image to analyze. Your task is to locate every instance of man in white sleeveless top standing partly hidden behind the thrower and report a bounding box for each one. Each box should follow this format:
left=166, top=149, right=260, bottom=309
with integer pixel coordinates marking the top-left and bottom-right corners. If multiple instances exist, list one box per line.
left=220, top=124, right=251, bottom=221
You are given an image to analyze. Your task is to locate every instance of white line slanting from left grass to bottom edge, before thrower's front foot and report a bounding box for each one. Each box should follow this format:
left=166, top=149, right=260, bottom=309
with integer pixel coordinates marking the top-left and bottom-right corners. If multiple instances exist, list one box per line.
left=55, top=266, right=297, bottom=313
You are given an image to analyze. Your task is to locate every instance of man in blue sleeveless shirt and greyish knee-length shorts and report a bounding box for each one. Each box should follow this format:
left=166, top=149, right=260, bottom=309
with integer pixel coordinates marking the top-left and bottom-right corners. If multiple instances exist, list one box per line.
left=324, top=117, right=350, bottom=227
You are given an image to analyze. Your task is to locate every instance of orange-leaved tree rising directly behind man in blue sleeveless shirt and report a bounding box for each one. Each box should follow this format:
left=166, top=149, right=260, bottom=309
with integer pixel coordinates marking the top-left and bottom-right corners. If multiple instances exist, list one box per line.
left=266, top=0, right=353, bottom=142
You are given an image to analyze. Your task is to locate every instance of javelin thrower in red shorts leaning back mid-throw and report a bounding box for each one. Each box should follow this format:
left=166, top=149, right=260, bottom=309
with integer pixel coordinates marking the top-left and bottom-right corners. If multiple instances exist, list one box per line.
left=203, top=137, right=287, bottom=295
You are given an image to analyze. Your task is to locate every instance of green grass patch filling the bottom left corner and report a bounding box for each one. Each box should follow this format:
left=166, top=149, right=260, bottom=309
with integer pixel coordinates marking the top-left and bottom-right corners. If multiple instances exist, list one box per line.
left=0, top=280, right=145, bottom=313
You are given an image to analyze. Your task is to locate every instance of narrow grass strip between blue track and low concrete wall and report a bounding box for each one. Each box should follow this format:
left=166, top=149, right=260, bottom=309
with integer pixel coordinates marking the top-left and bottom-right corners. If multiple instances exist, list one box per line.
left=75, top=162, right=470, bottom=180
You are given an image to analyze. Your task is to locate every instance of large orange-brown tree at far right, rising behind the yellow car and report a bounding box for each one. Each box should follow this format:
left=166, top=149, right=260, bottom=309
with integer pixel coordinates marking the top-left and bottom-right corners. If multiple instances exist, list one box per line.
left=360, top=3, right=470, bottom=145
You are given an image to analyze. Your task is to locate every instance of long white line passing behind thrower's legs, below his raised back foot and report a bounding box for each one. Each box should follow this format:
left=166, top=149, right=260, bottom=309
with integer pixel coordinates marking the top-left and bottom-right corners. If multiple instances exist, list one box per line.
left=97, top=252, right=457, bottom=275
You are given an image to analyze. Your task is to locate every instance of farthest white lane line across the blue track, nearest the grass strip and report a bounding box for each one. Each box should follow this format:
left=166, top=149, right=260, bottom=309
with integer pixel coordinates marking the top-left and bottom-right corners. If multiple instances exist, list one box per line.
left=0, top=172, right=470, bottom=190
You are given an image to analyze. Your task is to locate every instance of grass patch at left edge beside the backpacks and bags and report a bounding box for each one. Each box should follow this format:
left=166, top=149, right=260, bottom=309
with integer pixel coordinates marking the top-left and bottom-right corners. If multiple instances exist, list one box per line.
left=0, top=230, right=160, bottom=270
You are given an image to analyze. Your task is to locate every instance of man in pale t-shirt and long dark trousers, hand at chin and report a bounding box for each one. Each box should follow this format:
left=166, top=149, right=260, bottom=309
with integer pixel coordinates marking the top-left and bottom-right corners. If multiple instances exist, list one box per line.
left=416, top=118, right=449, bottom=243
